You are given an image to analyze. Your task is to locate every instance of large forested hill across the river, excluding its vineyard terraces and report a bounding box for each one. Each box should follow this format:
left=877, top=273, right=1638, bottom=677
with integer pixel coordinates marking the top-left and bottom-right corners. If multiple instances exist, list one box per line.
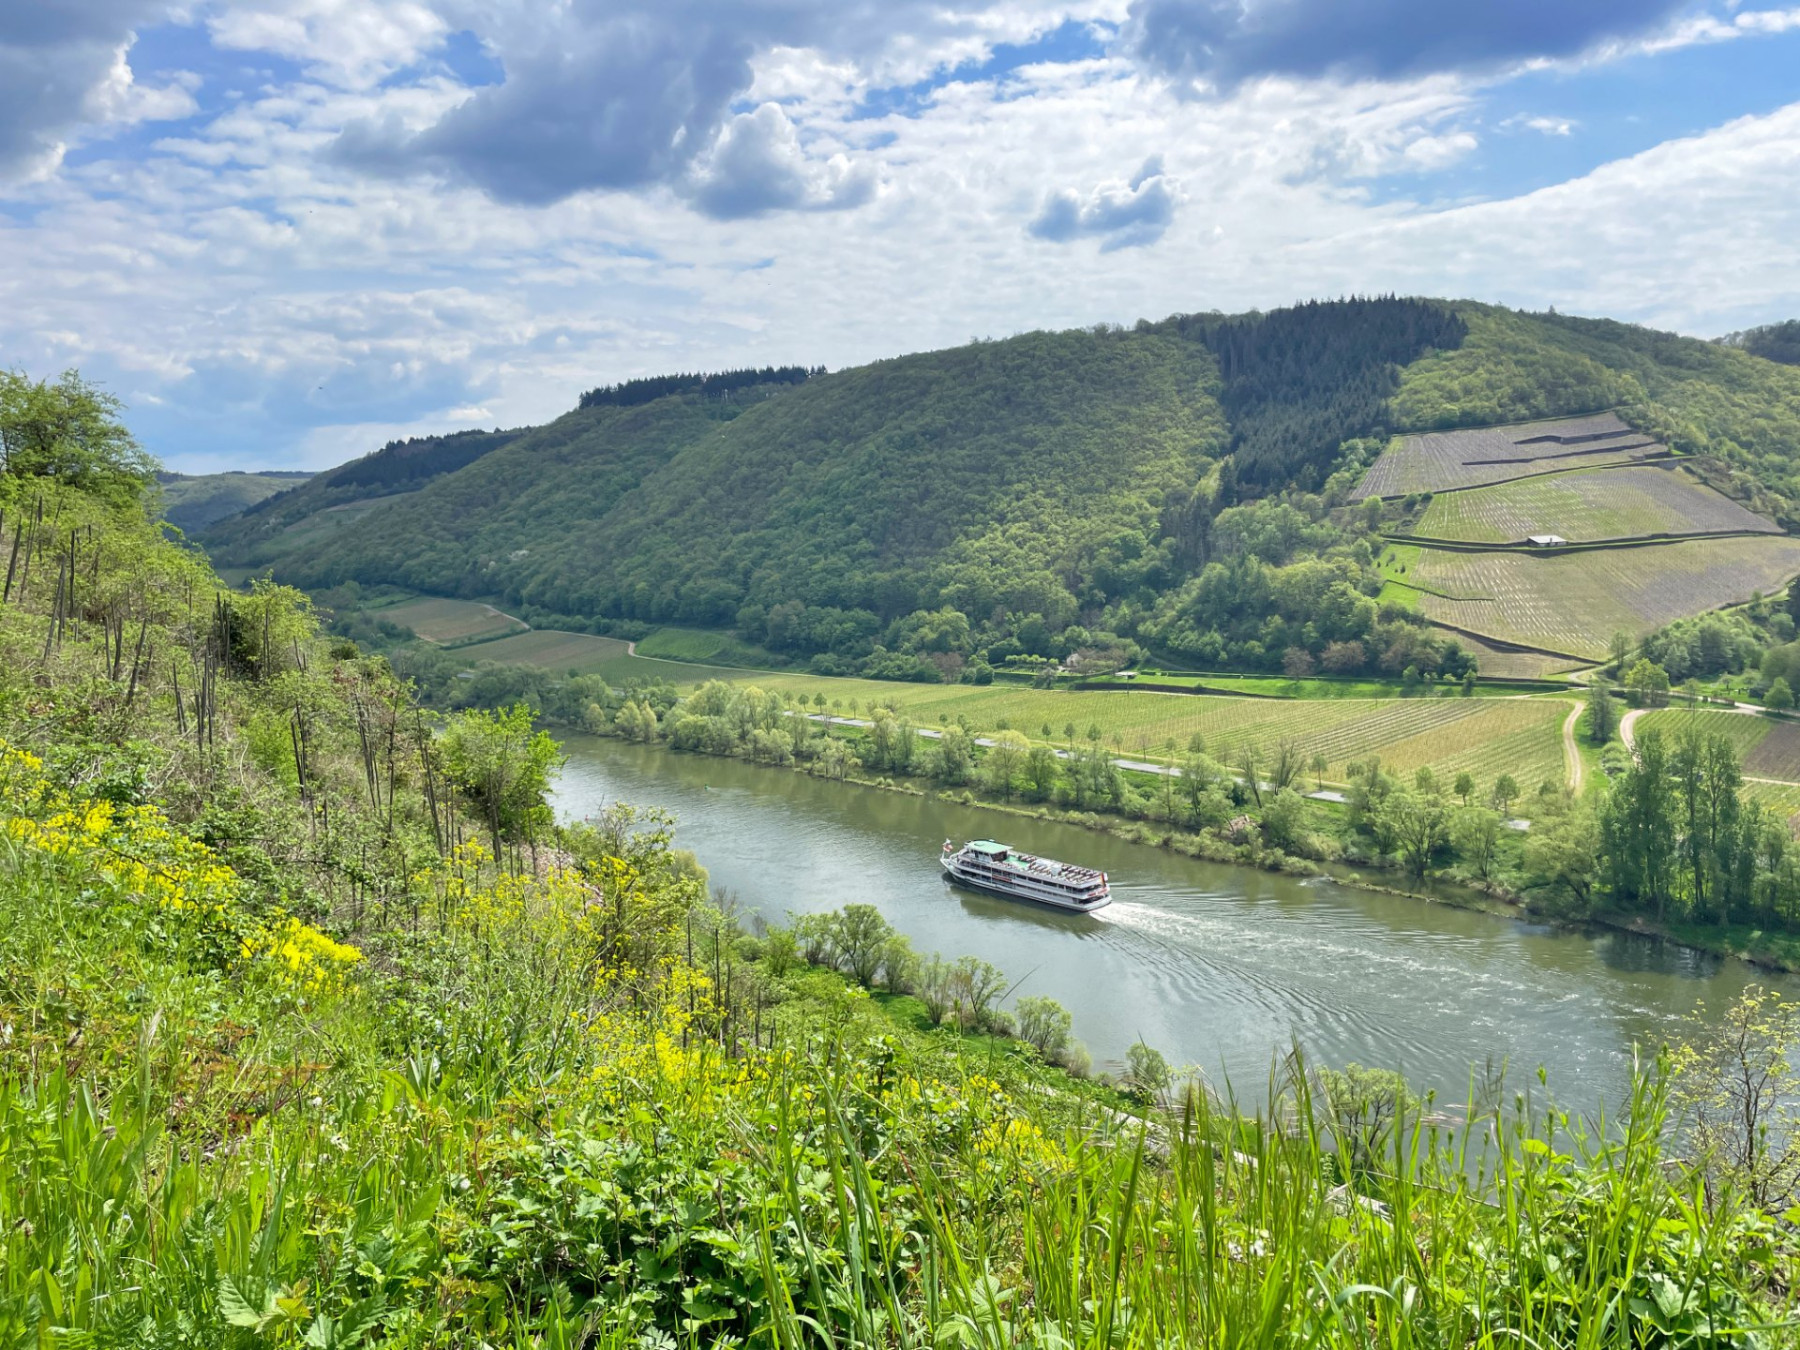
left=203, top=299, right=1800, bottom=675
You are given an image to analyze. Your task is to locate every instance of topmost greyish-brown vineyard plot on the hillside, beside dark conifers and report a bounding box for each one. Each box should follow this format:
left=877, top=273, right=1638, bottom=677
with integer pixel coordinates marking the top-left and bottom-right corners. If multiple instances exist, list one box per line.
left=1355, top=412, right=1667, bottom=497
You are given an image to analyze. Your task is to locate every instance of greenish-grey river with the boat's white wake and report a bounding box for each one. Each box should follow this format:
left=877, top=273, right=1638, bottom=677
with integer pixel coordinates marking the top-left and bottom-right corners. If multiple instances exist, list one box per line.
left=556, top=736, right=1800, bottom=1112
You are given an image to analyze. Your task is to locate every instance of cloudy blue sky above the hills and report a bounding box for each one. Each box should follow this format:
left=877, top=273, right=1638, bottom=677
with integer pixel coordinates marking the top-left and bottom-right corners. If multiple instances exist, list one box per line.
left=0, top=0, right=1800, bottom=472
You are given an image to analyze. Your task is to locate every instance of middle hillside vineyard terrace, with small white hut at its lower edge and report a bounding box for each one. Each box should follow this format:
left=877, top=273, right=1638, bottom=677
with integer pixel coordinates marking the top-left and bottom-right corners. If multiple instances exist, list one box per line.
left=1411, top=464, right=1780, bottom=544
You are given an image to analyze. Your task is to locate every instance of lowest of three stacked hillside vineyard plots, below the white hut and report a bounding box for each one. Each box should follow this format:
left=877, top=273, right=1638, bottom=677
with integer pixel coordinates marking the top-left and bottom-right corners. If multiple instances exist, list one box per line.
left=1406, top=536, right=1800, bottom=659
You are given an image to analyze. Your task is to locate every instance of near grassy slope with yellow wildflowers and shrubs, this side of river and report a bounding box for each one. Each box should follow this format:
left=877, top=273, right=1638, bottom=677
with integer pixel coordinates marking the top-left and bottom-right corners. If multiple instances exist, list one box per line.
left=0, top=367, right=1796, bottom=1350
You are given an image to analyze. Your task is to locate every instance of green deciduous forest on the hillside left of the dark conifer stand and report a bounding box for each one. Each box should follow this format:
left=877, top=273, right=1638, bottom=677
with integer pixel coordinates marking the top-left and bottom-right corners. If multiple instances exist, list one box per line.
left=262, top=333, right=1224, bottom=648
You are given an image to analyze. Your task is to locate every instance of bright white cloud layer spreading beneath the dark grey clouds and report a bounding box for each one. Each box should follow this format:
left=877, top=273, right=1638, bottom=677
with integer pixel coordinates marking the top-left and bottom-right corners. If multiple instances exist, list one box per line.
left=0, top=0, right=1800, bottom=466
